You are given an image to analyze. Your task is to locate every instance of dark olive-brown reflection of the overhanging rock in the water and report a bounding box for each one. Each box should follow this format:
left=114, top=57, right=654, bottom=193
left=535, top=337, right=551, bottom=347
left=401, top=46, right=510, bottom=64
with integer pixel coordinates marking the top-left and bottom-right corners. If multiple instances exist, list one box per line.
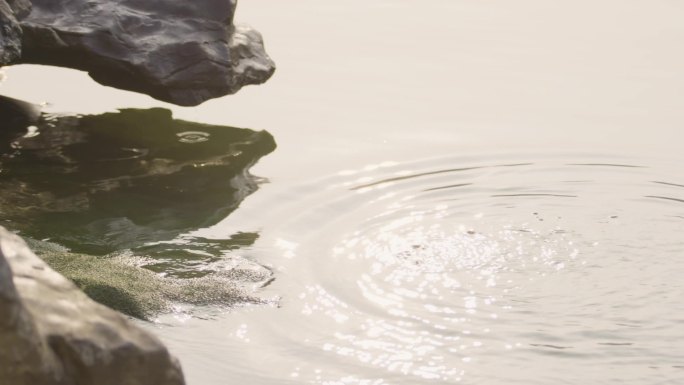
left=0, top=109, right=275, bottom=254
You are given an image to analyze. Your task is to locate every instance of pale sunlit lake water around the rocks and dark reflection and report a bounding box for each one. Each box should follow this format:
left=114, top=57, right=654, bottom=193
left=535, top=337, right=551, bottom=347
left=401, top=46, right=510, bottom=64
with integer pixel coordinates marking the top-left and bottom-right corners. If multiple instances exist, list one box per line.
left=0, top=0, right=684, bottom=385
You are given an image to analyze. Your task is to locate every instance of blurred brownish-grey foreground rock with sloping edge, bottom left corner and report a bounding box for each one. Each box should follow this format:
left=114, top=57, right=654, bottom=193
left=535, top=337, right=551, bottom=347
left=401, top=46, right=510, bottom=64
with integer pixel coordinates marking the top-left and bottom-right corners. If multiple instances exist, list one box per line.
left=0, top=227, right=184, bottom=385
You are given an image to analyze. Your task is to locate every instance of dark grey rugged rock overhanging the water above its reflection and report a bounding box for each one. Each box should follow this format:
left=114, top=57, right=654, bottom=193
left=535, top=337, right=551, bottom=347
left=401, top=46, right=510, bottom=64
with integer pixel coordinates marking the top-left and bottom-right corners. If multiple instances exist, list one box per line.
left=19, top=0, right=275, bottom=106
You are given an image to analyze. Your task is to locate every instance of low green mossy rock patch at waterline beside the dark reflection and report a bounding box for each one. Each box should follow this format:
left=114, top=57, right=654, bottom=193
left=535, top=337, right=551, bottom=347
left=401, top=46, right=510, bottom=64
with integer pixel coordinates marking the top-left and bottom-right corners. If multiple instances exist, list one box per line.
left=29, top=241, right=273, bottom=320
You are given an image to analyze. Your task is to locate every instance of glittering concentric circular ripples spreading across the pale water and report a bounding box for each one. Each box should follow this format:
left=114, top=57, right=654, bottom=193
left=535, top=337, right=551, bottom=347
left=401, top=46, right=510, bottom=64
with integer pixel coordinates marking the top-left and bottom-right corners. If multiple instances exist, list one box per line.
left=230, top=157, right=684, bottom=384
